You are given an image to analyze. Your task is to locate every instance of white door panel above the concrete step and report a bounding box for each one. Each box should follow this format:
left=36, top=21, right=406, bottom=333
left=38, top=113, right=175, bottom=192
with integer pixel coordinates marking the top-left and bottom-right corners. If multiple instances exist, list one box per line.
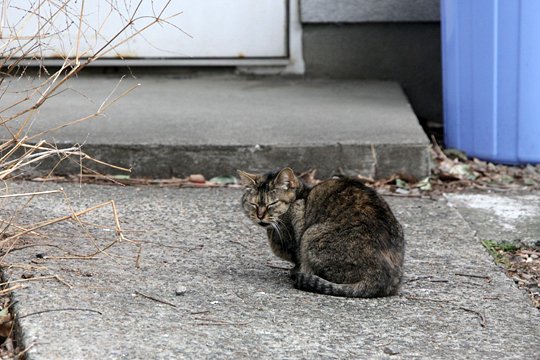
left=0, top=0, right=289, bottom=62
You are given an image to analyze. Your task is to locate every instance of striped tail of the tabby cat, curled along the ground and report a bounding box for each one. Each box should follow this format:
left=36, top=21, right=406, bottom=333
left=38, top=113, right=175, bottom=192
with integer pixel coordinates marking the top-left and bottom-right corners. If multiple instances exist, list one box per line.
left=294, top=272, right=397, bottom=298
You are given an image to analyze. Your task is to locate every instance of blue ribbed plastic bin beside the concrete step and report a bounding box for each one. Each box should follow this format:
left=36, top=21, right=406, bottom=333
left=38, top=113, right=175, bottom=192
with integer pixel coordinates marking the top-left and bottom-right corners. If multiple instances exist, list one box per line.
left=441, top=0, right=540, bottom=164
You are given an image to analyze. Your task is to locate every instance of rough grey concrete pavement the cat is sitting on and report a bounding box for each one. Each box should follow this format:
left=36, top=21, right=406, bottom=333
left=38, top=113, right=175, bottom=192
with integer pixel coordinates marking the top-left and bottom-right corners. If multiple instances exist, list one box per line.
left=1, top=183, right=540, bottom=360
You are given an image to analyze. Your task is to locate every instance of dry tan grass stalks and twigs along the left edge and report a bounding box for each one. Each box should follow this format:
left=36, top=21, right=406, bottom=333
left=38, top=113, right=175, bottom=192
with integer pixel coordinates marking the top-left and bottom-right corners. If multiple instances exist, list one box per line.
left=0, top=0, right=178, bottom=359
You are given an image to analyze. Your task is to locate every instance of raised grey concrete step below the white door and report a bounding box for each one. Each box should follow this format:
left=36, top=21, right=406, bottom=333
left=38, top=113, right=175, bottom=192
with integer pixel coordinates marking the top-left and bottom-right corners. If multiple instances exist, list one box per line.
left=0, top=75, right=430, bottom=178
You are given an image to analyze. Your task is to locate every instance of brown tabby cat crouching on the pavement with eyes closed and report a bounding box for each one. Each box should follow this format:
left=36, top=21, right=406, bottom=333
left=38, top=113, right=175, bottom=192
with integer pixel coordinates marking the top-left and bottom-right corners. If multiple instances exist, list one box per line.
left=238, top=168, right=405, bottom=298
